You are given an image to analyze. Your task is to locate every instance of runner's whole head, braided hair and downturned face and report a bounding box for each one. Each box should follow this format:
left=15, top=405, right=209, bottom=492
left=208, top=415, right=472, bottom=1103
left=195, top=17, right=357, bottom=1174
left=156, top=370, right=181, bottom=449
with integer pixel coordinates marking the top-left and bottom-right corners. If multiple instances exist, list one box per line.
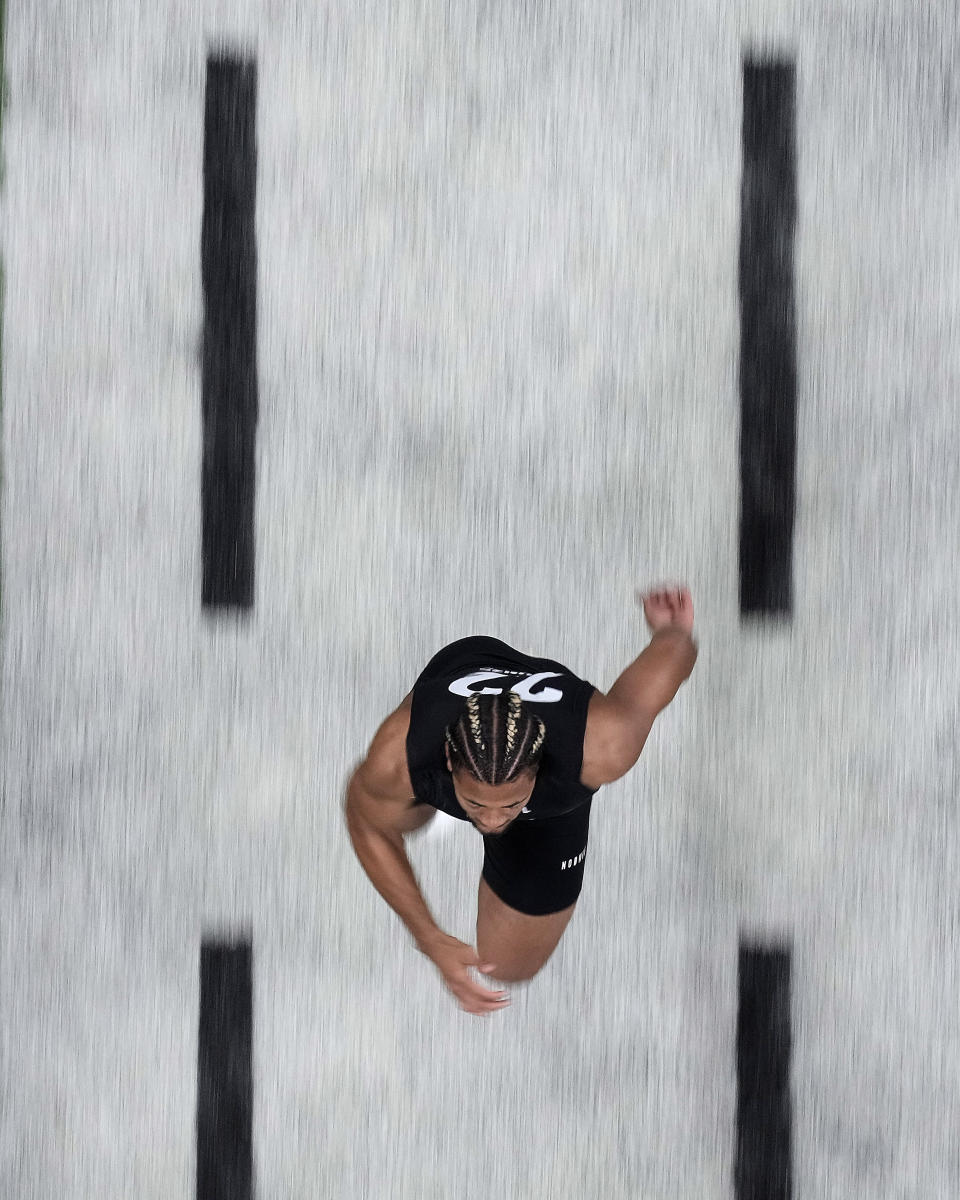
left=444, top=691, right=546, bottom=834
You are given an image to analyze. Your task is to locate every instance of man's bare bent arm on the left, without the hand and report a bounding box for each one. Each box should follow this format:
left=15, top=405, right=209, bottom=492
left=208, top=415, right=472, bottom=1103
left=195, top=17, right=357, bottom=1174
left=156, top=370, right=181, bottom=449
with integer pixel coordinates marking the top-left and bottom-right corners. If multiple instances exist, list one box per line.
left=344, top=726, right=445, bottom=955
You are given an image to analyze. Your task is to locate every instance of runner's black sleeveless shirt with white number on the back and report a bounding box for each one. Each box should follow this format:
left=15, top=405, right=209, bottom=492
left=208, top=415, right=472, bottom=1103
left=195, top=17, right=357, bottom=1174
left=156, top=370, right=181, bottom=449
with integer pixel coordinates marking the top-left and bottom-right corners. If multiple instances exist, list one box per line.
left=407, top=636, right=596, bottom=821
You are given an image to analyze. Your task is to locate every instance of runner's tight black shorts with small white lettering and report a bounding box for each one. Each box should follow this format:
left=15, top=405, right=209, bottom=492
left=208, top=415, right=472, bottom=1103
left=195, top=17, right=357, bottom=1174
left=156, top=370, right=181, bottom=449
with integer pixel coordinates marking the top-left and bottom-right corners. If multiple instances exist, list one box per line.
left=482, top=797, right=593, bottom=917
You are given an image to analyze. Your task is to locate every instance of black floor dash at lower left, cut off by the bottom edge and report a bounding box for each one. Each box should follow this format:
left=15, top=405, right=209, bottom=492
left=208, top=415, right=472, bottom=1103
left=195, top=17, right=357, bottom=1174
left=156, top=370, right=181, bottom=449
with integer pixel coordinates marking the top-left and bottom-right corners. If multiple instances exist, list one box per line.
left=197, top=941, right=253, bottom=1200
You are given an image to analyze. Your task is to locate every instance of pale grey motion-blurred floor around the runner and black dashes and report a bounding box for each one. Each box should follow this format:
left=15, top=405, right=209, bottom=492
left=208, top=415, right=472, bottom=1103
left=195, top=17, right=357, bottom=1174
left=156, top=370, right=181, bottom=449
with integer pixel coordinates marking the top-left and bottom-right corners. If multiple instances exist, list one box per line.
left=0, top=0, right=960, bottom=1200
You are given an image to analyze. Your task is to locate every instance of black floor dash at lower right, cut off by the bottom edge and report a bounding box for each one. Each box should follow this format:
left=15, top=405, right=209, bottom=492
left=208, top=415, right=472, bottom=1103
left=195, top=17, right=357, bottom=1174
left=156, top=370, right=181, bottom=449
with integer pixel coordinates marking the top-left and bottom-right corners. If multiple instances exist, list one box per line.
left=733, top=946, right=793, bottom=1200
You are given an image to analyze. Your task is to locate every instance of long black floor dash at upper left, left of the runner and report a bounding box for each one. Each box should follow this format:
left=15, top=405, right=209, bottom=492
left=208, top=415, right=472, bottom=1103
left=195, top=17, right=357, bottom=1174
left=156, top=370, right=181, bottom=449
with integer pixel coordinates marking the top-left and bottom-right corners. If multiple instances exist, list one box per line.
left=200, top=55, right=257, bottom=608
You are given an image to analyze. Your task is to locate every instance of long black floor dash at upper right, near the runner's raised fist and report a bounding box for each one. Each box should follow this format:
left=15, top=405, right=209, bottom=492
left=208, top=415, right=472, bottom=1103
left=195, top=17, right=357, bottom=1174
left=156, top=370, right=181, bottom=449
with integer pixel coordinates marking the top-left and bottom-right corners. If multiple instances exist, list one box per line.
left=739, top=60, right=797, bottom=616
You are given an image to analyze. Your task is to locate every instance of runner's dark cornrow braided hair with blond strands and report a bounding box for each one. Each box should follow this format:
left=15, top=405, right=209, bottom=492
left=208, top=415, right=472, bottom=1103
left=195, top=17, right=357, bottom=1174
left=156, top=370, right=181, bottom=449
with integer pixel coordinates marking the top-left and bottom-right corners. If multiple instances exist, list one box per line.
left=444, top=691, right=547, bottom=786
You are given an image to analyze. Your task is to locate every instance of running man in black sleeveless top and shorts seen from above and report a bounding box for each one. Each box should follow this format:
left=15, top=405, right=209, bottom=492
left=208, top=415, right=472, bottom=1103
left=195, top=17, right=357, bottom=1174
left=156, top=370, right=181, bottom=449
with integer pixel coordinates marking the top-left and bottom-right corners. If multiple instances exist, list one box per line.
left=346, top=587, right=697, bottom=1014
